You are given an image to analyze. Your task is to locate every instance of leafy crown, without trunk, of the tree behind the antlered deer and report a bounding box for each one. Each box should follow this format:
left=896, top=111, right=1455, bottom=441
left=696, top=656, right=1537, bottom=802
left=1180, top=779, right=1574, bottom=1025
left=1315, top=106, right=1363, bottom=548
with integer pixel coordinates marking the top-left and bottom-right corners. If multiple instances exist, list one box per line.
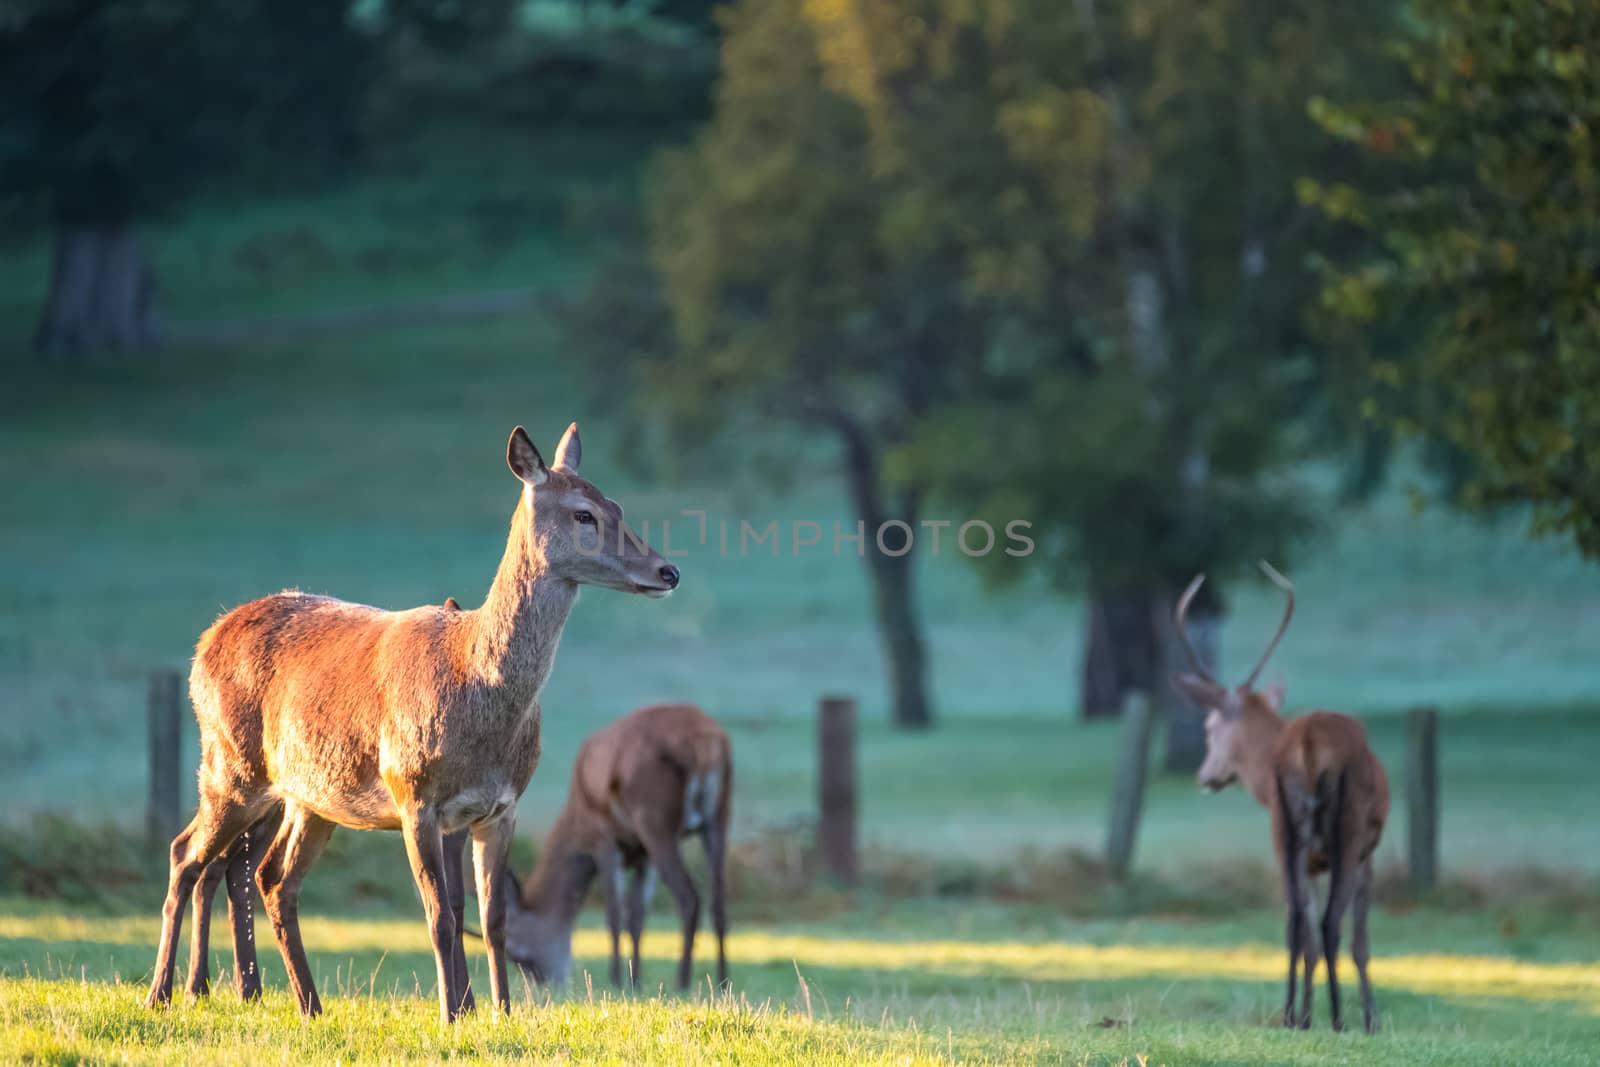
left=918, top=3, right=1389, bottom=585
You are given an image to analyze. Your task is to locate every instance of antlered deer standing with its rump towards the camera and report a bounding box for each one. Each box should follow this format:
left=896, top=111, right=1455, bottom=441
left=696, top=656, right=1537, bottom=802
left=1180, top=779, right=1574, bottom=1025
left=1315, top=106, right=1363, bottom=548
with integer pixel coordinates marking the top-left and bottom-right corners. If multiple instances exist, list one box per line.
left=1173, top=560, right=1389, bottom=1033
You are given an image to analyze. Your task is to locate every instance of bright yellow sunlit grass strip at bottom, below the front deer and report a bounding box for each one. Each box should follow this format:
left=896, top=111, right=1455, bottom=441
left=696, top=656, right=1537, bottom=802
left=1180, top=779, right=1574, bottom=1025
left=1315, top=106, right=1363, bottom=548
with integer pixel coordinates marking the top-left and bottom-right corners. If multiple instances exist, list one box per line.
left=0, top=981, right=1006, bottom=1067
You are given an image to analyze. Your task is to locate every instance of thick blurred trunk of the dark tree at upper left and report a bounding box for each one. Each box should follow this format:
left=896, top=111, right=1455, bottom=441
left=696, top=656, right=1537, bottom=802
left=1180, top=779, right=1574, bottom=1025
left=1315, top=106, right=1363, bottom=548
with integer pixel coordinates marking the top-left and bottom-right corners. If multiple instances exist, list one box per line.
left=34, top=226, right=157, bottom=360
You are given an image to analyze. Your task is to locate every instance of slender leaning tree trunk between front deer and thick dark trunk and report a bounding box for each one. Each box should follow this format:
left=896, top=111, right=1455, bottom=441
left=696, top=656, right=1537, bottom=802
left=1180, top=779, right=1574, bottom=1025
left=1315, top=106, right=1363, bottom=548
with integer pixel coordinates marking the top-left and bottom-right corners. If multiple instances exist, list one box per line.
left=830, top=414, right=933, bottom=729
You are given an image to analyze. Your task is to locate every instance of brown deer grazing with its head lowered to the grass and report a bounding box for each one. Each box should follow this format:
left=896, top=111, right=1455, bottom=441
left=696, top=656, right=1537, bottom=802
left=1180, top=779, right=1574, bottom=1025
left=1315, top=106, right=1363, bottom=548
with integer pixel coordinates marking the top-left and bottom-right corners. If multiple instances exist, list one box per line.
left=506, top=704, right=733, bottom=989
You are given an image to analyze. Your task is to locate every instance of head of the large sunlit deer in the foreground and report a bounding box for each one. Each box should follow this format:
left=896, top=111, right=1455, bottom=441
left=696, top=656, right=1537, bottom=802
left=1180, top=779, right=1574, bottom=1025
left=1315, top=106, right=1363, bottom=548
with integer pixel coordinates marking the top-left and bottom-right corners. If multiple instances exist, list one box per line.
left=506, top=422, right=678, bottom=597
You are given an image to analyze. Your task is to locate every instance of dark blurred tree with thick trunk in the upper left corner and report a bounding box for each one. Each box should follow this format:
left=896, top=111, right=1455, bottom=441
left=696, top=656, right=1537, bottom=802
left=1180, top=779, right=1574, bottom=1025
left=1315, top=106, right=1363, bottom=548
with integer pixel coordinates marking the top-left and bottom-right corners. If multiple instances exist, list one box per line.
left=0, top=0, right=371, bottom=357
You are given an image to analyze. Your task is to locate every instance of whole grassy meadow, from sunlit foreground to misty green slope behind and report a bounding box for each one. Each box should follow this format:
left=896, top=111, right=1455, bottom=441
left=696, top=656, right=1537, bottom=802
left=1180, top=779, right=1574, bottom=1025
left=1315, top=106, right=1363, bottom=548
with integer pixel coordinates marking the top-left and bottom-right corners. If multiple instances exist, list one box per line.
left=0, top=129, right=1600, bottom=1064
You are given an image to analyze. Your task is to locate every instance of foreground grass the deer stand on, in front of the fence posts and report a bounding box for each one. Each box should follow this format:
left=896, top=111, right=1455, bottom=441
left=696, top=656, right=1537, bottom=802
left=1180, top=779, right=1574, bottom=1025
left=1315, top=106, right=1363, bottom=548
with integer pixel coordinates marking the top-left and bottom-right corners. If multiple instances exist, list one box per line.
left=0, top=901, right=1600, bottom=1064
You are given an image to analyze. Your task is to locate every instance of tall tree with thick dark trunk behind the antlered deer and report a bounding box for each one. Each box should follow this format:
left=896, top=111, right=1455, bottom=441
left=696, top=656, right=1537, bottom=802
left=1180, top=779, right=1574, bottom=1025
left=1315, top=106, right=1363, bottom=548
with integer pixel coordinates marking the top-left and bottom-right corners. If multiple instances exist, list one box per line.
left=921, top=0, right=1392, bottom=769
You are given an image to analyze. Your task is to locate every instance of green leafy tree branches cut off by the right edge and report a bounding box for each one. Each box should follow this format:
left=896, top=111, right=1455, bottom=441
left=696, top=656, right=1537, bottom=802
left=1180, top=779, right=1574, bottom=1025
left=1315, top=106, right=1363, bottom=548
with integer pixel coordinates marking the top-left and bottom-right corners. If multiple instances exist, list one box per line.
left=1301, top=0, right=1600, bottom=558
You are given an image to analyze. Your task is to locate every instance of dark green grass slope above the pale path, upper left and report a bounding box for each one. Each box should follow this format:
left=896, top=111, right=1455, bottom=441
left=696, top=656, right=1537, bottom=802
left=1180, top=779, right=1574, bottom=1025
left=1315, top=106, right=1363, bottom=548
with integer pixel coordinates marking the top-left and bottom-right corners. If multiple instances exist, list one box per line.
left=0, top=120, right=670, bottom=335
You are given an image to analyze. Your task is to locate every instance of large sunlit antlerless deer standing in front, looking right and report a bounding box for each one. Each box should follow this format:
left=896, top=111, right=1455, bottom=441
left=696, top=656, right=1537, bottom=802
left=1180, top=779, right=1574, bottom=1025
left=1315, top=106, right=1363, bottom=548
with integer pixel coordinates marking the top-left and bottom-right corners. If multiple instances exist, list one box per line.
left=146, top=424, right=680, bottom=1022
